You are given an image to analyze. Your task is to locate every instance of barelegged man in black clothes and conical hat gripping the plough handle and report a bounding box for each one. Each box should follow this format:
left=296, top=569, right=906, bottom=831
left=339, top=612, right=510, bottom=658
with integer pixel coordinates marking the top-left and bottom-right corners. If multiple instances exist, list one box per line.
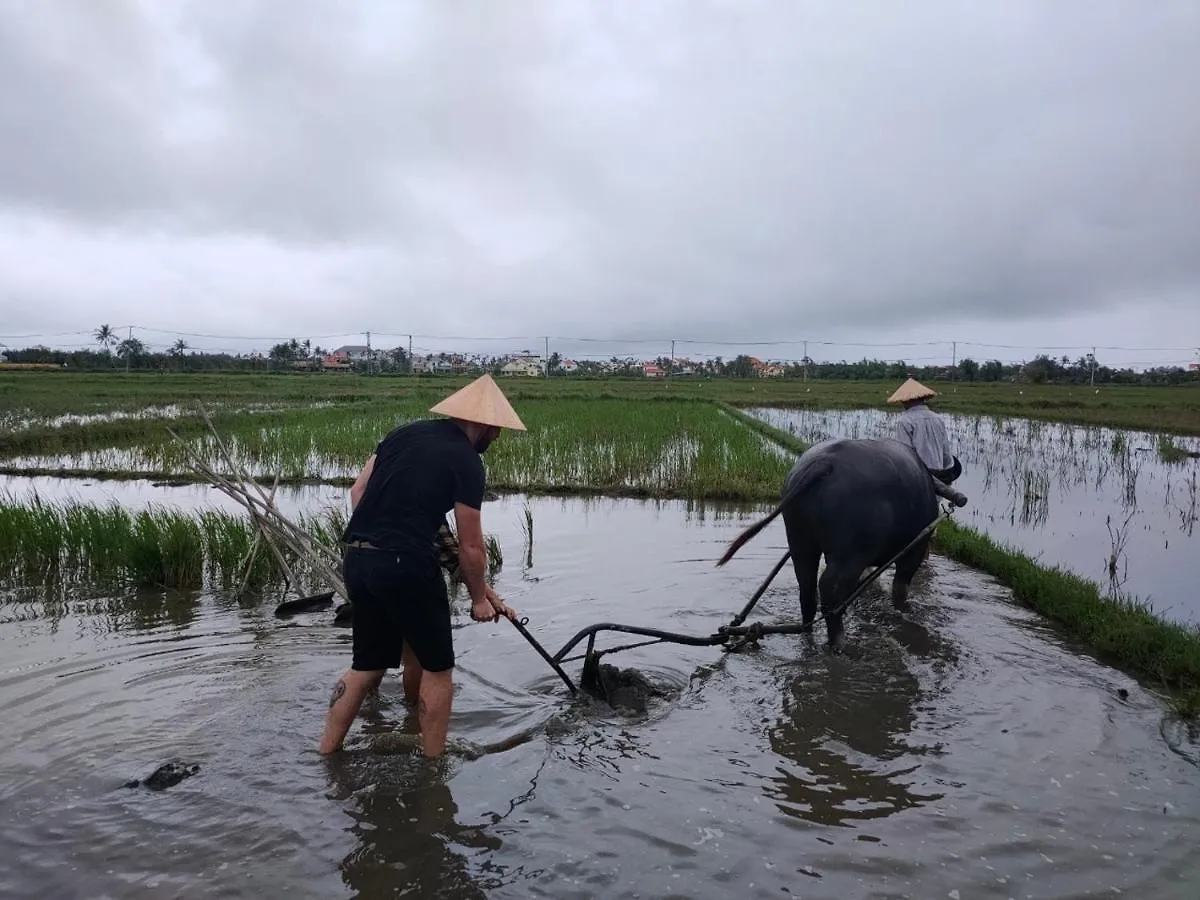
left=319, top=374, right=526, bottom=756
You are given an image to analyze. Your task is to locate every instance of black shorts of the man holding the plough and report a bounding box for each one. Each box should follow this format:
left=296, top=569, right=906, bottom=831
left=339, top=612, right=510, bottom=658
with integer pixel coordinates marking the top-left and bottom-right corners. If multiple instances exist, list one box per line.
left=343, top=547, right=454, bottom=672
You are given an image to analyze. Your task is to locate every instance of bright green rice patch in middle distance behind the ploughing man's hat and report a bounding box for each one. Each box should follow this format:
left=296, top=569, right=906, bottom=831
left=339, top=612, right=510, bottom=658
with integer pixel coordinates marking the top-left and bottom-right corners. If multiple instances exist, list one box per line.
left=9, top=400, right=790, bottom=499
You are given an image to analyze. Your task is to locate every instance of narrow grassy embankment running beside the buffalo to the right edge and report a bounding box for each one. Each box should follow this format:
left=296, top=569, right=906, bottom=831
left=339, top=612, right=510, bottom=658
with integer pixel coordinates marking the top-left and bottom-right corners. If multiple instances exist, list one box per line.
left=720, top=413, right=1200, bottom=718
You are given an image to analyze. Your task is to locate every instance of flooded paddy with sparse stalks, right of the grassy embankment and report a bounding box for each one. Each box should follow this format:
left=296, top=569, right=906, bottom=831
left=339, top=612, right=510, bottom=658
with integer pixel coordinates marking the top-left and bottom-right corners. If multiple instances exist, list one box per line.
left=748, top=408, right=1200, bottom=623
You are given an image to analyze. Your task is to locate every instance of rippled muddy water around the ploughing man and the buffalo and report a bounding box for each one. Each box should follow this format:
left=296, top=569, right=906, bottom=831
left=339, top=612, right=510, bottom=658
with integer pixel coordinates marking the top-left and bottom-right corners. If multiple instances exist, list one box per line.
left=0, top=498, right=1200, bottom=899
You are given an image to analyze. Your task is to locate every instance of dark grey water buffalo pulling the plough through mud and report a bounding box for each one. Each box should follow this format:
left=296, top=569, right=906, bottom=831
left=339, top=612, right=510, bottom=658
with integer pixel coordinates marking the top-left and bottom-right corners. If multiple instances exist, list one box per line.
left=718, top=438, right=938, bottom=650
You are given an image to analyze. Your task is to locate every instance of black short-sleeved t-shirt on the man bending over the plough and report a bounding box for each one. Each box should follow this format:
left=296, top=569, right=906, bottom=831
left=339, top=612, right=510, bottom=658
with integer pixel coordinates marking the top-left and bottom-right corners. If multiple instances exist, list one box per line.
left=343, top=419, right=485, bottom=564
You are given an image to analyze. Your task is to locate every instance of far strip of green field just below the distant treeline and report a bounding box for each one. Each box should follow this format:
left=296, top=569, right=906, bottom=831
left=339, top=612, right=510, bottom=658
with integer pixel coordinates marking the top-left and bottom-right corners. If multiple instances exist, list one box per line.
left=7, top=372, right=1200, bottom=434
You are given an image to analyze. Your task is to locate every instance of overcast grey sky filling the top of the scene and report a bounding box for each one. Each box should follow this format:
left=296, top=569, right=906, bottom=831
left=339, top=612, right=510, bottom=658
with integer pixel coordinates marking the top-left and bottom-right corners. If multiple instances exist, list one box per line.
left=0, top=0, right=1200, bottom=364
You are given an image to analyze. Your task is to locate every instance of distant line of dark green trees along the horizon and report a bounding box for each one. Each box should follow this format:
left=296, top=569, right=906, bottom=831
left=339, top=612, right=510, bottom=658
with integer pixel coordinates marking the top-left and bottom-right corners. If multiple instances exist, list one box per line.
left=4, top=337, right=1200, bottom=385
